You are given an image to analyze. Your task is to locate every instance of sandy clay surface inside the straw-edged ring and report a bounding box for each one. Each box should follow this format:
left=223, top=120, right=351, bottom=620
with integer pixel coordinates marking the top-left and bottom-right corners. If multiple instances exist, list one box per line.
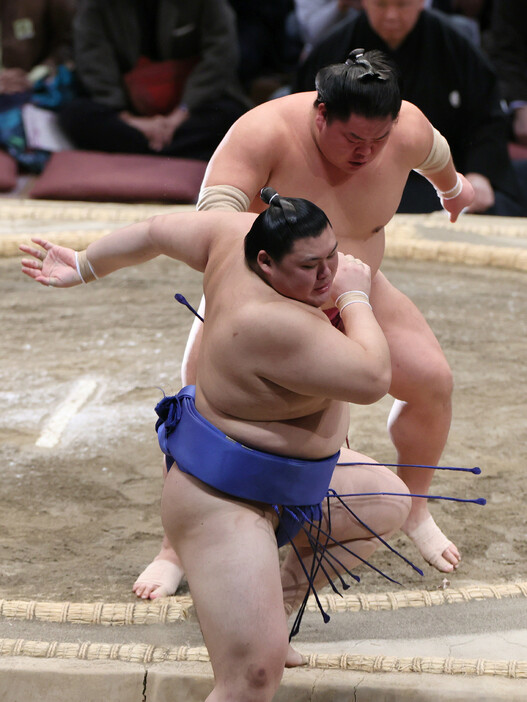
left=0, top=258, right=527, bottom=602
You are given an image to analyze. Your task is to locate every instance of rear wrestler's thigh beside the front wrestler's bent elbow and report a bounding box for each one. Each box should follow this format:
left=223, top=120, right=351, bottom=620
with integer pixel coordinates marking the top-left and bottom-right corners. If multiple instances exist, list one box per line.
left=370, top=271, right=452, bottom=401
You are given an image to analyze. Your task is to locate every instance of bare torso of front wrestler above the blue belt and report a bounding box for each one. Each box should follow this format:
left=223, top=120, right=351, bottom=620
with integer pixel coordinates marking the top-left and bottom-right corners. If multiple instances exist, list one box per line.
left=196, top=228, right=349, bottom=459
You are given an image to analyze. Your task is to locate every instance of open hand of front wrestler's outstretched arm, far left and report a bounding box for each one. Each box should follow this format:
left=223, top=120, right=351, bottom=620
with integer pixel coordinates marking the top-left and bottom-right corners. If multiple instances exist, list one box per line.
left=19, top=237, right=82, bottom=288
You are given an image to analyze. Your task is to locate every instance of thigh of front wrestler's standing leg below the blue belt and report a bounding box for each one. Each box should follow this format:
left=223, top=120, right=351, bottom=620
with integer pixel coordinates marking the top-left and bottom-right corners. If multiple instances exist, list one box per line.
left=161, top=466, right=288, bottom=679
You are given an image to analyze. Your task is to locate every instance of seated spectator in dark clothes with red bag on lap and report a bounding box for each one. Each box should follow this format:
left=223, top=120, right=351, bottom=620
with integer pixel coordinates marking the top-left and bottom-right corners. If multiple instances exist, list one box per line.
left=61, top=0, right=249, bottom=160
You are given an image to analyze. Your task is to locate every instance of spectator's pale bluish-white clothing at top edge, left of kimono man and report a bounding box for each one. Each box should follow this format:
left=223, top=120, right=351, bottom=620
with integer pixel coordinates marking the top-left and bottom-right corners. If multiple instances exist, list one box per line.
left=295, top=0, right=361, bottom=55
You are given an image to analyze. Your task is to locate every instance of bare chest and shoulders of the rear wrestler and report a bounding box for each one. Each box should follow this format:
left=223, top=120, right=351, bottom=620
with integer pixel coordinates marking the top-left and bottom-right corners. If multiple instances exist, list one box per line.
left=204, top=92, right=431, bottom=274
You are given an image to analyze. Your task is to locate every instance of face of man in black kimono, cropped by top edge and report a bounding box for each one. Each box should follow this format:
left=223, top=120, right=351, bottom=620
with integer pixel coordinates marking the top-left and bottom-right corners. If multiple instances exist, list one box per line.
left=362, top=0, right=425, bottom=49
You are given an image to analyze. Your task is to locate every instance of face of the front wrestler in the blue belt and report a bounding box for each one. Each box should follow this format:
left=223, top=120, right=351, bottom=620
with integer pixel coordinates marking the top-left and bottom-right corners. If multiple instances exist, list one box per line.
left=258, top=227, right=338, bottom=307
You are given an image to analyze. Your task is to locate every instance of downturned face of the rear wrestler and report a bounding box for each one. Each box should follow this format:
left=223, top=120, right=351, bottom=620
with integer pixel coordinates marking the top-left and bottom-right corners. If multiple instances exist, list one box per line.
left=315, top=110, right=395, bottom=175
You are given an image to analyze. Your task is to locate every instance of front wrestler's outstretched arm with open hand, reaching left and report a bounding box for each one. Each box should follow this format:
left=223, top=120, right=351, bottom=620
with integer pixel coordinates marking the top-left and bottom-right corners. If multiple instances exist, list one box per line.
left=20, top=212, right=254, bottom=288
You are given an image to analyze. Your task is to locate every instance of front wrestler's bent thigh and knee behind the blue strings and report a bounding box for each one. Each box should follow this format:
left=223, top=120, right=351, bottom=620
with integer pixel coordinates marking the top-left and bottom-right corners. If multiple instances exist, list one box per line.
left=320, top=448, right=412, bottom=541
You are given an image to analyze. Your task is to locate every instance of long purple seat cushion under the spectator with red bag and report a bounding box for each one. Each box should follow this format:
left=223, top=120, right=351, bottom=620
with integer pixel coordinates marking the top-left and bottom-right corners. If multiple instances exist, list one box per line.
left=29, top=151, right=207, bottom=204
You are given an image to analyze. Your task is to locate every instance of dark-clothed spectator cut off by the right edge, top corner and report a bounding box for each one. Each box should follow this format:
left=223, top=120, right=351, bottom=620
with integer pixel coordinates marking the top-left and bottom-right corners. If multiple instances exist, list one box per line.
left=490, top=0, right=527, bottom=146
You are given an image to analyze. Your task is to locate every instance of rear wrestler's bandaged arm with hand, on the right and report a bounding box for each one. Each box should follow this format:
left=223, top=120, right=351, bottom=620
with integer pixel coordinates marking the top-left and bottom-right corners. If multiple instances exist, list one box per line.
left=400, top=102, right=474, bottom=222
